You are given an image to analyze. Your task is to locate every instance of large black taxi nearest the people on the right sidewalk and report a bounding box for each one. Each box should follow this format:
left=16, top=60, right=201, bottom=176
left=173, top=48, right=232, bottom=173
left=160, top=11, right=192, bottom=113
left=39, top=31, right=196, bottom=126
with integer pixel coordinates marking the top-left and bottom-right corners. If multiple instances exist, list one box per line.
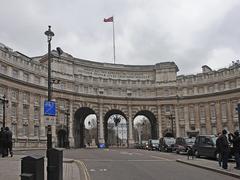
left=192, top=135, right=218, bottom=159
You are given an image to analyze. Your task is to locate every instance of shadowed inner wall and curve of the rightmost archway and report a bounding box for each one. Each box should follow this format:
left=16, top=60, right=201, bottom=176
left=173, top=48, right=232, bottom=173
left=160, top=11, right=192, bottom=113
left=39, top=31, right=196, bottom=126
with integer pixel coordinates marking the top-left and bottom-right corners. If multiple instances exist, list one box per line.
left=133, top=110, right=158, bottom=139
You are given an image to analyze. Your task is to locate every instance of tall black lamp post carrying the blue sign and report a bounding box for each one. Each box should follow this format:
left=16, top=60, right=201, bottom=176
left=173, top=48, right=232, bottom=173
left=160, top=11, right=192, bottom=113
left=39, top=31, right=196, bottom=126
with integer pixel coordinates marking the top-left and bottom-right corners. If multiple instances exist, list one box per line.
left=45, top=26, right=54, bottom=149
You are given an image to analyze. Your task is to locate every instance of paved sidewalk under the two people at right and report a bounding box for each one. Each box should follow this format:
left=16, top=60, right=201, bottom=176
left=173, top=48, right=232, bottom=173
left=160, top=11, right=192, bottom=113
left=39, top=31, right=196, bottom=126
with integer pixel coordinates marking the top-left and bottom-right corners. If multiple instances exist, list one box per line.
left=176, top=157, right=240, bottom=178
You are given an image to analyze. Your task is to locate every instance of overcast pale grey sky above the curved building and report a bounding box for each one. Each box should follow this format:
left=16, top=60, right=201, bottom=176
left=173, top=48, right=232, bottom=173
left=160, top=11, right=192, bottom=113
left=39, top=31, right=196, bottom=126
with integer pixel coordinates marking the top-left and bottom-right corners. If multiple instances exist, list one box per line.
left=0, top=0, right=240, bottom=74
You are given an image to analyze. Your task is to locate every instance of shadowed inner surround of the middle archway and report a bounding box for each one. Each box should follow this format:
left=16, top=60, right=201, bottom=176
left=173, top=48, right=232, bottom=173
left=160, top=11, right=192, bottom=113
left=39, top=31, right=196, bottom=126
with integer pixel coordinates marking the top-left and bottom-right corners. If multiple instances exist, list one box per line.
left=103, top=109, right=128, bottom=147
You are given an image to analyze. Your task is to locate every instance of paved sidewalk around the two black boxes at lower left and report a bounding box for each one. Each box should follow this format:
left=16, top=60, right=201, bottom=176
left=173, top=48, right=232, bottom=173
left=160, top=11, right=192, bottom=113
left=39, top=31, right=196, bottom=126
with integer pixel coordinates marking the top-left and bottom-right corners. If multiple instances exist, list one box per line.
left=0, top=155, right=80, bottom=180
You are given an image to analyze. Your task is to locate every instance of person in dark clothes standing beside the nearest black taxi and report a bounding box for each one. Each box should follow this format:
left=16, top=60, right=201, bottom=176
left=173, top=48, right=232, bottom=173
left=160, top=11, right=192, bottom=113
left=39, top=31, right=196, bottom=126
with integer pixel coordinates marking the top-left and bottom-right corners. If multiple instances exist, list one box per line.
left=218, top=129, right=229, bottom=169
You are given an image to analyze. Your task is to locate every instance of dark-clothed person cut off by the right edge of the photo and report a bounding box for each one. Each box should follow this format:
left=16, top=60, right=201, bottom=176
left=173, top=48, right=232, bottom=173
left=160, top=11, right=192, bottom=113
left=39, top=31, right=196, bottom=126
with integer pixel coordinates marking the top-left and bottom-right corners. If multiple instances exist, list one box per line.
left=228, top=130, right=240, bottom=170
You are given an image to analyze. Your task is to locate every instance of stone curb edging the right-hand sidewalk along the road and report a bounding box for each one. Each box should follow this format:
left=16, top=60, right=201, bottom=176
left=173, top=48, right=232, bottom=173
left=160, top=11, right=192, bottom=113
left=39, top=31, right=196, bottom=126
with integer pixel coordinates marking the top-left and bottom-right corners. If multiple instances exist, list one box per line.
left=176, top=159, right=240, bottom=178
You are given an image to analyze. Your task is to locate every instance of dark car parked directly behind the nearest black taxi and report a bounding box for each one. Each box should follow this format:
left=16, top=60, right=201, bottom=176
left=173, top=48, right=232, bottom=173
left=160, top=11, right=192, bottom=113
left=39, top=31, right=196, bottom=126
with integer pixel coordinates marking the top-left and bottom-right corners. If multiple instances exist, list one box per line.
left=174, top=137, right=196, bottom=154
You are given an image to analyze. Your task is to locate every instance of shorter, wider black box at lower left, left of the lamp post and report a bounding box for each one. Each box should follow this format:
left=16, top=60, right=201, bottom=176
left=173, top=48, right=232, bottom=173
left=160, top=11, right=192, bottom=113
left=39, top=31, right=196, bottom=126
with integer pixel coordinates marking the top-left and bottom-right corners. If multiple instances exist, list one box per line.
left=20, top=155, right=44, bottom=180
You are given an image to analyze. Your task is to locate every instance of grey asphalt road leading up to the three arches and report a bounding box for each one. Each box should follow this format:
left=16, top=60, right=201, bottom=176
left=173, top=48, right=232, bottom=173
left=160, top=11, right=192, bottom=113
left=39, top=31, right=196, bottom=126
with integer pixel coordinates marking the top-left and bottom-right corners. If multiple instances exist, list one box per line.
left=14, top=149, right=237, bottom=180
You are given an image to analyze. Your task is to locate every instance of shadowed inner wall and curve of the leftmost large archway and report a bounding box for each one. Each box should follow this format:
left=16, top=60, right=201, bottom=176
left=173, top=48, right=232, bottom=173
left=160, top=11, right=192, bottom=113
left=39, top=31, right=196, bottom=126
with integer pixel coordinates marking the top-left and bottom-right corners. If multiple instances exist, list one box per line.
left=73, top=107, right=98, bottom=148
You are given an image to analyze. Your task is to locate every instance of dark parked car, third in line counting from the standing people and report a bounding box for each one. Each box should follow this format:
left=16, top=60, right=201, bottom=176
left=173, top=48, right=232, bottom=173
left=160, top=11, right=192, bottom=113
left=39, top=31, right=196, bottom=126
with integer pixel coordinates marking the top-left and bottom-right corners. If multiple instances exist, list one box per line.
left=159, top=137, right=176, bottom=152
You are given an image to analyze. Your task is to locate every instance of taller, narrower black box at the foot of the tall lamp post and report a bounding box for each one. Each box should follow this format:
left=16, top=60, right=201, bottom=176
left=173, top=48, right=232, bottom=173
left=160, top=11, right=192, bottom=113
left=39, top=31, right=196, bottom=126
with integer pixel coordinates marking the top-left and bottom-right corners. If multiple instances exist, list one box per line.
left=47, top=148, right=63, bottom=180
